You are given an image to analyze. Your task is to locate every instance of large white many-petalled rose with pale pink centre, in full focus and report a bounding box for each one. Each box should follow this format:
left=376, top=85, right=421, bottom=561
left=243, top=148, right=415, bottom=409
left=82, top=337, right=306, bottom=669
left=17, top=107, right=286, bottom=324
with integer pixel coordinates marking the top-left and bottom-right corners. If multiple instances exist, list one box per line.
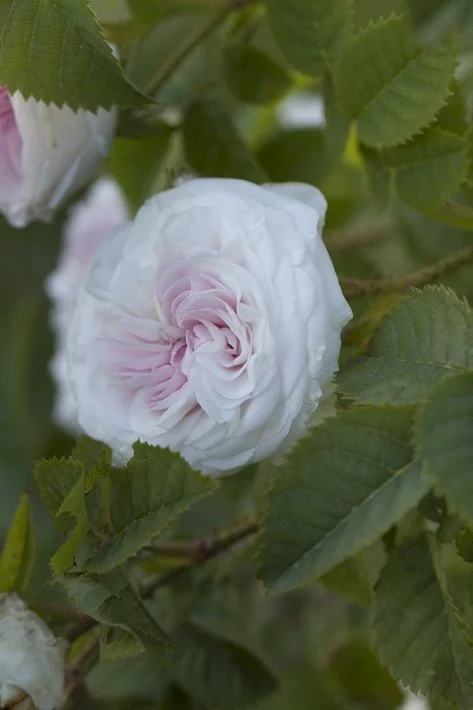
left=68, top=179, right=352, bottom=476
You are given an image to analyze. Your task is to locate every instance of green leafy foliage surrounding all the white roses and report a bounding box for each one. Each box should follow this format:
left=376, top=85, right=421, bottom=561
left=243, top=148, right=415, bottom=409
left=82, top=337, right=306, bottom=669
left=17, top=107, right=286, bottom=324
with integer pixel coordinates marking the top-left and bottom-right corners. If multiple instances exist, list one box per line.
left=0, top=0, right=473, bottom=710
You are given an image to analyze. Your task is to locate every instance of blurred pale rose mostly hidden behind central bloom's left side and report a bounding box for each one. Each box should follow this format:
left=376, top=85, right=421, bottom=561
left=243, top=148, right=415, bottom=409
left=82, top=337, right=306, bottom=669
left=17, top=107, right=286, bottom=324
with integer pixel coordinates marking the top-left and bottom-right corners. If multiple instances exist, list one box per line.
left=46, top=178, right=128, bottom=433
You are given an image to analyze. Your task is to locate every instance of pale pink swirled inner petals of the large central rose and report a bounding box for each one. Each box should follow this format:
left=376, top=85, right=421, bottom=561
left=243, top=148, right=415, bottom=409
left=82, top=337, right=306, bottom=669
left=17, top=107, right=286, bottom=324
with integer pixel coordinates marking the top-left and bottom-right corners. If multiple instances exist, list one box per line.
left=106, top=263, right=252, bottom=418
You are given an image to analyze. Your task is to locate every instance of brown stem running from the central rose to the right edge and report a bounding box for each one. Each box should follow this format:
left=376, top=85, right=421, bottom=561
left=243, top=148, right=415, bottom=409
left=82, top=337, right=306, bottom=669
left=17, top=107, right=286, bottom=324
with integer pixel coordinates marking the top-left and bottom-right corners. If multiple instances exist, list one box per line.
left=339, top=246, right=473, bottom=299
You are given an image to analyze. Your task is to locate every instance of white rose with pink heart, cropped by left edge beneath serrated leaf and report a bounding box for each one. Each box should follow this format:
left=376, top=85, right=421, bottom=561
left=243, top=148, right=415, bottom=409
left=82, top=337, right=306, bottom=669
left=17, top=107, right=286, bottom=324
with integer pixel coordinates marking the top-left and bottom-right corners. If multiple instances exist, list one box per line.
left=0, top=86, right=116, bottom=227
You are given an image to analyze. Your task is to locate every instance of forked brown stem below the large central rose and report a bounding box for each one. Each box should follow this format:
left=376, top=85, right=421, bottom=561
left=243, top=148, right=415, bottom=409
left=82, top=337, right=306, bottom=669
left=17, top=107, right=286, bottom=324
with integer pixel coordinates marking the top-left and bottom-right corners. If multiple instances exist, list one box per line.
left=138, top=521, right=259, bottom=599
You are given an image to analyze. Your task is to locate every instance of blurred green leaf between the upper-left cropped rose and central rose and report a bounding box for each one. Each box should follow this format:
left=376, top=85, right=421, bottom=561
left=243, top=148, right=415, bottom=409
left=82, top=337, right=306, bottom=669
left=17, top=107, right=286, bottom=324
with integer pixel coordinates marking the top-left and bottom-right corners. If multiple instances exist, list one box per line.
left=109, top=126, right=173, bottom=212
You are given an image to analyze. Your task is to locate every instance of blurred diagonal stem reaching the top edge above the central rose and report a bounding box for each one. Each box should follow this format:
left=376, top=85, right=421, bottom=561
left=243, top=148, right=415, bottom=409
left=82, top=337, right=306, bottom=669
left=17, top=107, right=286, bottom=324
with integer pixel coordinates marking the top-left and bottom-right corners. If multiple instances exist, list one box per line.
left=145, top=0, right=251, bottom=94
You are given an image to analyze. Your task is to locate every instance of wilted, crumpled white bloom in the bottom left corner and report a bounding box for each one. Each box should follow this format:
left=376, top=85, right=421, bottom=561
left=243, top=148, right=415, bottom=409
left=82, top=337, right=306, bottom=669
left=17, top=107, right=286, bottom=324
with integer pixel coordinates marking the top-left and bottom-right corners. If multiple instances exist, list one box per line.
left=0, top=594, right=67, bottom=710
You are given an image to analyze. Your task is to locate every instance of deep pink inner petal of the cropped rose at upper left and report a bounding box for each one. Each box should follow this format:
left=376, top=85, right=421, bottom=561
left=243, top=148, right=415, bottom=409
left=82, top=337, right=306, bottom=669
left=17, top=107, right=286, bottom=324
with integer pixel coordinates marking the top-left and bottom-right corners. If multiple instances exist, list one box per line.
left=0, top=86, right=22, bottom=188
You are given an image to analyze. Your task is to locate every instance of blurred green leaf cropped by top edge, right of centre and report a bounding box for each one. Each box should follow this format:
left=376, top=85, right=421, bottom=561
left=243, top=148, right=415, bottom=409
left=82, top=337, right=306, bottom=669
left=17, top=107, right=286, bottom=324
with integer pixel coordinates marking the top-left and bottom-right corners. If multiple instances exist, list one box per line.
left=266, top=0, right=351, bottom=77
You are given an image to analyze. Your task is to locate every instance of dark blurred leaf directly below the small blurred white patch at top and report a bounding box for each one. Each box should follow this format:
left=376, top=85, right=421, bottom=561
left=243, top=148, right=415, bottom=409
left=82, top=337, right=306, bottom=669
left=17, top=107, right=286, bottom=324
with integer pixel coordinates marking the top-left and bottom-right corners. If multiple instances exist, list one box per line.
left=258, top=128, right=330, bottom=185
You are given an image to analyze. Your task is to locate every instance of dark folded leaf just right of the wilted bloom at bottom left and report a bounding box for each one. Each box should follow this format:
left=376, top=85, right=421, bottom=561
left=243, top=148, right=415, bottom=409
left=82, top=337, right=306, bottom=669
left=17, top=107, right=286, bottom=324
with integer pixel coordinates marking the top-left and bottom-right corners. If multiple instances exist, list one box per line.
left=61, top=570, right=170, bottom=650
